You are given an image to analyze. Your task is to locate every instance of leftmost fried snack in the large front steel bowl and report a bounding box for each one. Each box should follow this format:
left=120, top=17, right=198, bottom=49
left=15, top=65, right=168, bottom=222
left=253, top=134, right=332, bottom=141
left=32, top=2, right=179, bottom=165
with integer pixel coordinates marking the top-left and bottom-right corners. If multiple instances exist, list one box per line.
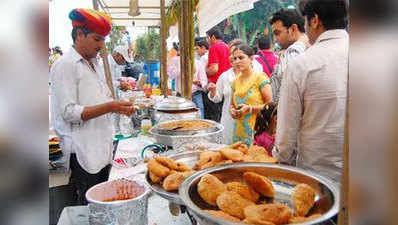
left=197, top=174, right=227, bottom=206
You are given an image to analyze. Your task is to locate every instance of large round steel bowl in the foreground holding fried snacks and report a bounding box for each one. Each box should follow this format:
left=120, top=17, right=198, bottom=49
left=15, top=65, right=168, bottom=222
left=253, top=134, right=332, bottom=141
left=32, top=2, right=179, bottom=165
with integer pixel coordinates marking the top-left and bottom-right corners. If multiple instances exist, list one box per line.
left=179, top=163, right=340, bottom=225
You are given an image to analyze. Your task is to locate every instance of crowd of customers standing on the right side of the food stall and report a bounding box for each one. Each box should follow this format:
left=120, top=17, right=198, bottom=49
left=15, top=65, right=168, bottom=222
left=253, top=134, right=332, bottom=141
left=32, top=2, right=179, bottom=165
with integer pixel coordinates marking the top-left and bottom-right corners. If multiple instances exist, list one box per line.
left=168, top=0, right=348, bottom=181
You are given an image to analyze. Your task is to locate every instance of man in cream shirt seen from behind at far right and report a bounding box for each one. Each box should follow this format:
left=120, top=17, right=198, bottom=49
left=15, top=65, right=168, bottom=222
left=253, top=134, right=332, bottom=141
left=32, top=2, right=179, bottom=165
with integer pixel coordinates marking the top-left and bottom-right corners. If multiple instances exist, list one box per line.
left=273, top=0, right=349, bottom=181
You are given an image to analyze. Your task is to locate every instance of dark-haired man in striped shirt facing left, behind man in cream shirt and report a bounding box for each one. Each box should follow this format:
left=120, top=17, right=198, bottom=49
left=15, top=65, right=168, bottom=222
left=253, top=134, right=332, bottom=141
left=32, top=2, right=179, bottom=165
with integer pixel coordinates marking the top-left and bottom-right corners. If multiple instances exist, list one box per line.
left=268, top=9, right=309, bottom=102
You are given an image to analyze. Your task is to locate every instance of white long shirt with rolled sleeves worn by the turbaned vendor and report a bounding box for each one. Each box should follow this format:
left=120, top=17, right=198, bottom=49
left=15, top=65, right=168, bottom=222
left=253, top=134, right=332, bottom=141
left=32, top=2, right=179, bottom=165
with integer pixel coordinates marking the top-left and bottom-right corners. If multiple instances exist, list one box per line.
left=50, top=48, right=113, bottom=174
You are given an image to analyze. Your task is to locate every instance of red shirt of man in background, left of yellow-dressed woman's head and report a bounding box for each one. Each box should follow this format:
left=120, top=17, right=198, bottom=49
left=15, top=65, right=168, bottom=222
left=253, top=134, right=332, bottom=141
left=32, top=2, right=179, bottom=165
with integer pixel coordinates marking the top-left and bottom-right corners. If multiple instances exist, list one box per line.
left=207, top=40, right=231, bottom=83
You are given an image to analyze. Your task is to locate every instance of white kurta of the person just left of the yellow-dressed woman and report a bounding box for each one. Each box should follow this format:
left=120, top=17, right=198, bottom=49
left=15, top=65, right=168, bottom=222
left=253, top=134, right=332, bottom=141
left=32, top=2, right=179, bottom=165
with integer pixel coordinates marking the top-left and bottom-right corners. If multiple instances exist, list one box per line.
left=208, top=68, right=235, bottom=145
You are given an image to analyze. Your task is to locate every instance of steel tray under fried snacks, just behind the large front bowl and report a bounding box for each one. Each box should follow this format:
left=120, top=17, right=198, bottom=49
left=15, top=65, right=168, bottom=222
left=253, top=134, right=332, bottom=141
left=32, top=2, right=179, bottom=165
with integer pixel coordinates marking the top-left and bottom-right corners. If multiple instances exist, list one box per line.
left=145, top=151, right=201, bottom=205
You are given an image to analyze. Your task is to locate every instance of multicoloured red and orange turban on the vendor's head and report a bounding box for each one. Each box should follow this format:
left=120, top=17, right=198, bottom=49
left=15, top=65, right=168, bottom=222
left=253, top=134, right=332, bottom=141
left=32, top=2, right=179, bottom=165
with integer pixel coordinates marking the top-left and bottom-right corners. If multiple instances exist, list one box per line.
left=69, top=9, right=112, bottom=36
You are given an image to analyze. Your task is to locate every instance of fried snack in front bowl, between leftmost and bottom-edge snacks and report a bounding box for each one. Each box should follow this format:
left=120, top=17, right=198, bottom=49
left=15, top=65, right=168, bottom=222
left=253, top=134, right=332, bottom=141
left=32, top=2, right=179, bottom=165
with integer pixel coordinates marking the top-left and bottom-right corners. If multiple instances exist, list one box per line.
left=217, top=191, right=255, bottom=219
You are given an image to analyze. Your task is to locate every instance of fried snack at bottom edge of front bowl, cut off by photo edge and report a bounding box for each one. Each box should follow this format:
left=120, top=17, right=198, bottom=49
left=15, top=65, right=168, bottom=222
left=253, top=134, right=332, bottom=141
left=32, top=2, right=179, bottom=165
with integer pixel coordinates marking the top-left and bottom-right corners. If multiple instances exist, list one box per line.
left=244, top=203, right=292, bottom=225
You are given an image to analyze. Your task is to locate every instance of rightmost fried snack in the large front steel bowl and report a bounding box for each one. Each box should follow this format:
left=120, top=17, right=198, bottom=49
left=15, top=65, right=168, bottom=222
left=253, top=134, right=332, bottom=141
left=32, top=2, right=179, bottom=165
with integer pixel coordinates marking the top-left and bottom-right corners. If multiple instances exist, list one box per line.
left=292, top=184, right=315, bottom=216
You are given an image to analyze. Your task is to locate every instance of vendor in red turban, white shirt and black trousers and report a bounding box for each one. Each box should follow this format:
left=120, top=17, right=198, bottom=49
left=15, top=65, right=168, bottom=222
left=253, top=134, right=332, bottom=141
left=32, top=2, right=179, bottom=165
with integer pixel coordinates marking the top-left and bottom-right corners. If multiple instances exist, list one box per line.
left=50, top=9, right=134, bottom=204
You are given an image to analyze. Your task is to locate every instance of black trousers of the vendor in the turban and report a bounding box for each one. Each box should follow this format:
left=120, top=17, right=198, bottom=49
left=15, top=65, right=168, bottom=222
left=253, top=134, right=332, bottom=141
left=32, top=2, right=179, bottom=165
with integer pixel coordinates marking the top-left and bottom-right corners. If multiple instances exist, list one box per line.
left=69, top=153, right=111, bottom=205
